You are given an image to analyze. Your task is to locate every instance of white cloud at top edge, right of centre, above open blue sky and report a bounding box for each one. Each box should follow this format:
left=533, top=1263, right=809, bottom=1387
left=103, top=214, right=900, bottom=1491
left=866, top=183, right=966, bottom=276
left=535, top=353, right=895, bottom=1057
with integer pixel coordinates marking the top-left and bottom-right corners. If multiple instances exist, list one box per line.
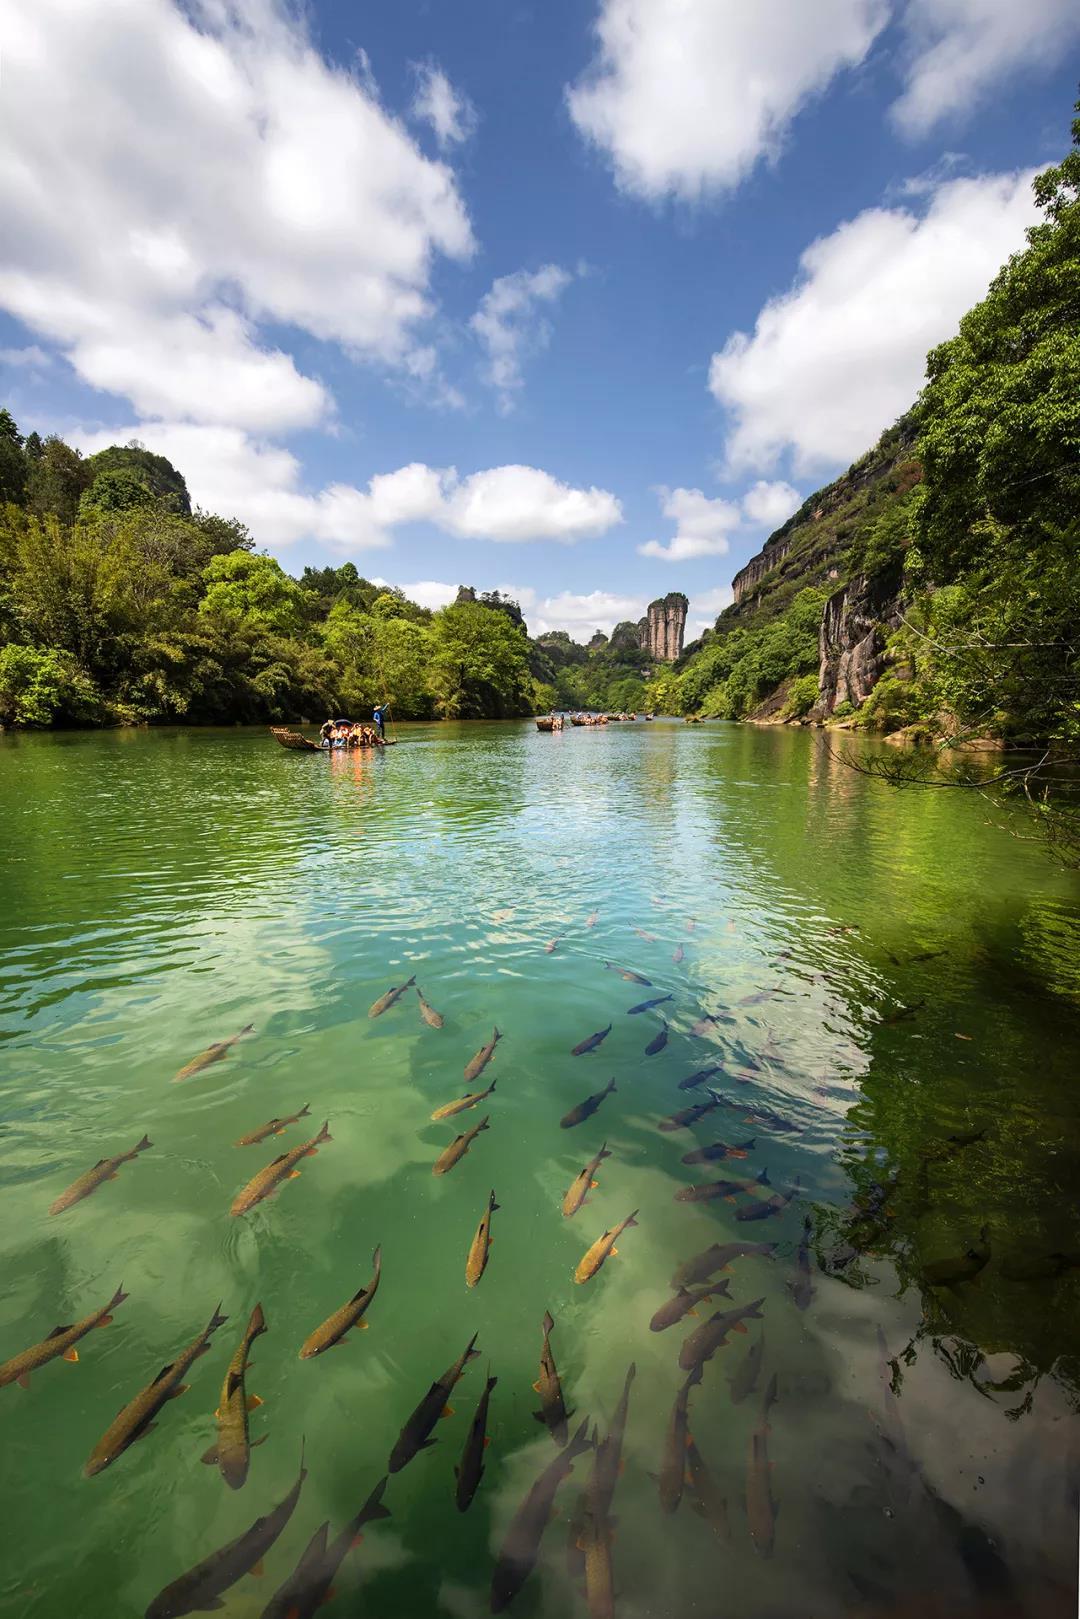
left=567, top=0, right=887, bottom=201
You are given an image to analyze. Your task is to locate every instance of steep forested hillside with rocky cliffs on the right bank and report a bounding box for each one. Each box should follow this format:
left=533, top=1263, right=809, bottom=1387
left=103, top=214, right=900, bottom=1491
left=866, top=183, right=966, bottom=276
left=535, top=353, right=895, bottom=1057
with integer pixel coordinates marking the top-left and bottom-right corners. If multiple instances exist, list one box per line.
left=651, top=108, right=1080, bottom=788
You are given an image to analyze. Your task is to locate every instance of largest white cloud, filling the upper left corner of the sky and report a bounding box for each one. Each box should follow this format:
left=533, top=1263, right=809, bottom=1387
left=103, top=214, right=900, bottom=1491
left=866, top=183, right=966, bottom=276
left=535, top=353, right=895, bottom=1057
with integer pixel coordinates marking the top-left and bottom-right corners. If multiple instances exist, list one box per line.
left=0, top=0, right=473, bottom=432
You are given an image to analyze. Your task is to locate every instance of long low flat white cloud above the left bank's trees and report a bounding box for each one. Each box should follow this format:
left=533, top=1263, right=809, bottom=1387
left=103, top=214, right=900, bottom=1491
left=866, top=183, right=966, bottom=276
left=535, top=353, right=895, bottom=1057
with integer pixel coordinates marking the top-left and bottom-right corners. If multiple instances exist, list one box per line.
left=68, top=421, right=622, bottom=552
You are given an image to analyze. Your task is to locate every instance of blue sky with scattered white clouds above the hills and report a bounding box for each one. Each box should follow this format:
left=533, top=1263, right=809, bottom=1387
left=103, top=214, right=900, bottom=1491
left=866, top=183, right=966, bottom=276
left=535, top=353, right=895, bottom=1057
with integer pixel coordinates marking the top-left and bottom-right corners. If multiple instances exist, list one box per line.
left=0, top=0, right=1080, bottom=638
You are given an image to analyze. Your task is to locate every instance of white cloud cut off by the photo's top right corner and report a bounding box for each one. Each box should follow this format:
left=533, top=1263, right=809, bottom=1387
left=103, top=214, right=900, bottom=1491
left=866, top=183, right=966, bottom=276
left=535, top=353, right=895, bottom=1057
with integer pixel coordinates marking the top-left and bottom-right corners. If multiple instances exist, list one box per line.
left=892, top=0, right=1080, bottom=136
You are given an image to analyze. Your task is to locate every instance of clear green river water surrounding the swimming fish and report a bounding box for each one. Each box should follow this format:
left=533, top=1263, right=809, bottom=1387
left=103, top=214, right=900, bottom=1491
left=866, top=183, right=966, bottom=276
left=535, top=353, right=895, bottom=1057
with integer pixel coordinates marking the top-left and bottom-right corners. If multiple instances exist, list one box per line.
left=0, top=720, right=1080, bottom=1619
